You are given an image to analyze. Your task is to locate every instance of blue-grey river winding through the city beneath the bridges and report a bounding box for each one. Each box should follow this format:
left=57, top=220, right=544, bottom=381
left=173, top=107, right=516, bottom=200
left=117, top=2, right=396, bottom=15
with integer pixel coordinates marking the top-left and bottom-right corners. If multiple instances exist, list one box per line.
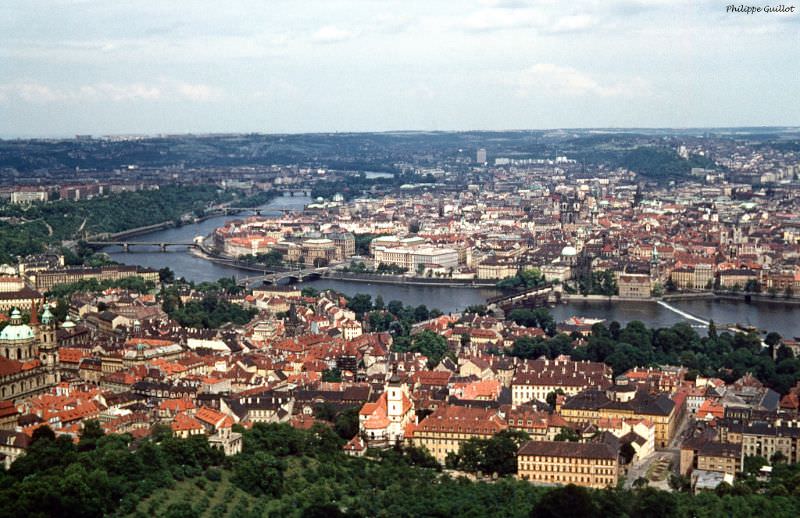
left=104, top=196, right=800, bottom=337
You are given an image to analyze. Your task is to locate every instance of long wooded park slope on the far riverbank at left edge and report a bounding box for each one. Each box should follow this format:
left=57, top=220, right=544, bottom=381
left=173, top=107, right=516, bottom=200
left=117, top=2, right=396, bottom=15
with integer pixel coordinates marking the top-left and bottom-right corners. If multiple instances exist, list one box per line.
left=0, top=185, right=236, bottom=263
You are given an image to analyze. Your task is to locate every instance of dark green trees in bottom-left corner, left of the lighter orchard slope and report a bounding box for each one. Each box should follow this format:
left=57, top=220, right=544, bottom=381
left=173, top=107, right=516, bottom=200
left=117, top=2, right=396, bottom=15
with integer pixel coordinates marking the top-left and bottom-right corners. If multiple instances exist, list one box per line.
left=0, top=425, right=222, bottom=517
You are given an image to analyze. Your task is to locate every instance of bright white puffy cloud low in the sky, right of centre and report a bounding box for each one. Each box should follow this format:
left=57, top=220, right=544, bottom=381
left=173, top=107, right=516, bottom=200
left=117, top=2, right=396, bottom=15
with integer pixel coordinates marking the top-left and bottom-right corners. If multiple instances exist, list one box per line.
left=511, top=63, right=650, bottom=97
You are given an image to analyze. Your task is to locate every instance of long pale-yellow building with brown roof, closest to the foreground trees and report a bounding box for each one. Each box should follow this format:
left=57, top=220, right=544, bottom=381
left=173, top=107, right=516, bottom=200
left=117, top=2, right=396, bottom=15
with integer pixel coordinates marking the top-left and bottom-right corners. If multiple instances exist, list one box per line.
left=517, top=441, right=619, bottom=490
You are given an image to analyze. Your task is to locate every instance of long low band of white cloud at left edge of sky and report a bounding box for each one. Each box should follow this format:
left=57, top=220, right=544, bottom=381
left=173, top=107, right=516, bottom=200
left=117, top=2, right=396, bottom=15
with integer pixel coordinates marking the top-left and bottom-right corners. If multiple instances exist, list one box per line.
left=0, top=79, right=223, bottom=104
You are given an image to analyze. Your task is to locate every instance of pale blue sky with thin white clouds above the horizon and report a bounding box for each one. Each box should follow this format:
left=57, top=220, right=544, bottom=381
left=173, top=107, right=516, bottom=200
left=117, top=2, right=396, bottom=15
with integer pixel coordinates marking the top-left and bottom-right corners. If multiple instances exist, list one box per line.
left=0, top=0, right=800, bottom=138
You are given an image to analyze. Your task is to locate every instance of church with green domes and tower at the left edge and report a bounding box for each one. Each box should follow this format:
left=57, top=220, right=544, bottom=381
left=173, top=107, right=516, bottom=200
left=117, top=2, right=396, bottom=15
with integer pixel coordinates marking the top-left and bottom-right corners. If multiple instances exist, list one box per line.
left=0, top=305, right=60, bottom=402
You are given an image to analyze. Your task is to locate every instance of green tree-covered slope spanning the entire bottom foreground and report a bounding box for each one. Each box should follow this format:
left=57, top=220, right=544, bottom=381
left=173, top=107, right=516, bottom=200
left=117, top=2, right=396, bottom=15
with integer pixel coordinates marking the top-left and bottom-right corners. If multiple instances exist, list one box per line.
left=0, top=421, right=800, bottom=518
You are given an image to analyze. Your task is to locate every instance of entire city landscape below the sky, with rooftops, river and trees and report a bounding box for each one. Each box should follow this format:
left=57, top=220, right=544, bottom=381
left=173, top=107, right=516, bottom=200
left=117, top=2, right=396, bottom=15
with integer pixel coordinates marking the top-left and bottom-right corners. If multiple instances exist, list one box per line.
left=0, top=128, right=800, bottom=516
